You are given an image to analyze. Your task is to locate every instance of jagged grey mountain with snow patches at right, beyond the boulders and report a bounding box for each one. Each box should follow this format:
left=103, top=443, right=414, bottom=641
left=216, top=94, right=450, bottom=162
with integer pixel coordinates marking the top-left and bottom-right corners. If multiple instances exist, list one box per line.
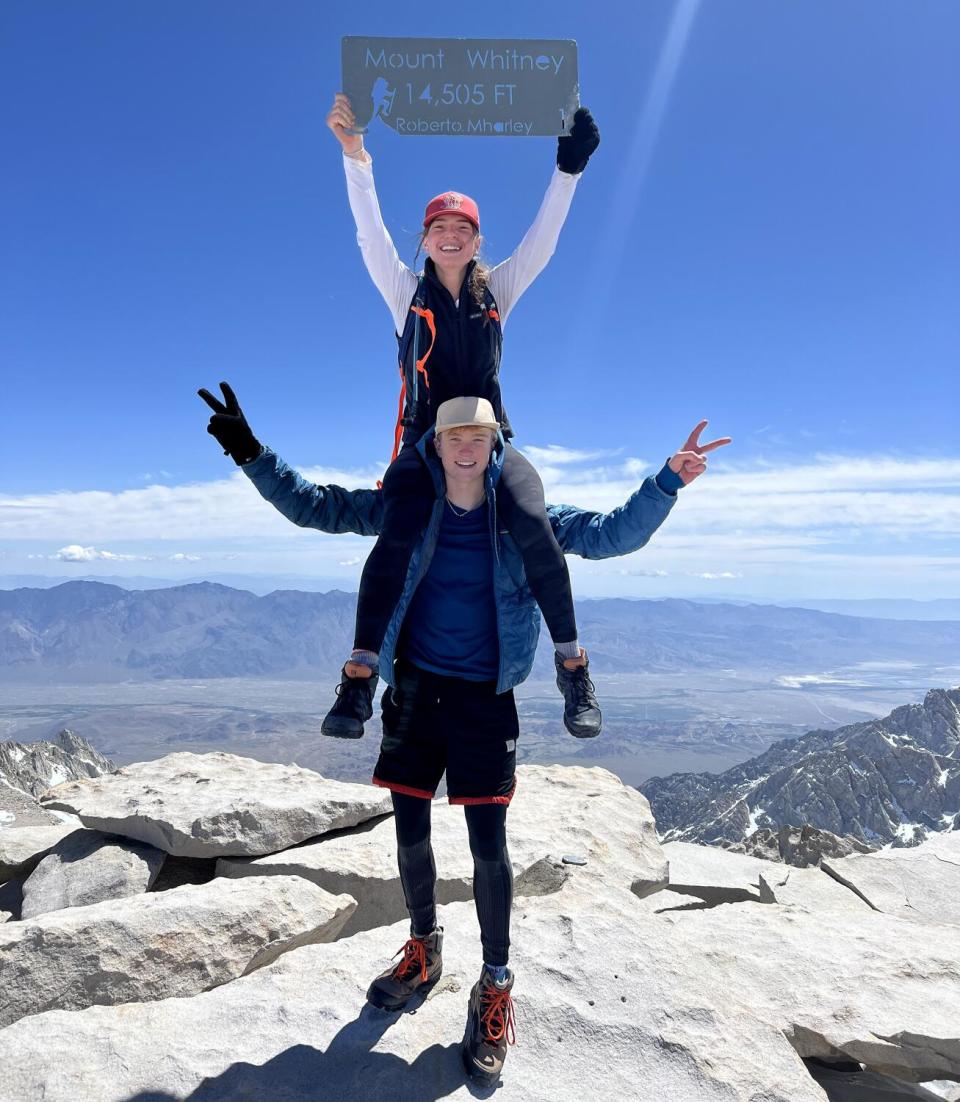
left=639, top=689, right=960, bottom=849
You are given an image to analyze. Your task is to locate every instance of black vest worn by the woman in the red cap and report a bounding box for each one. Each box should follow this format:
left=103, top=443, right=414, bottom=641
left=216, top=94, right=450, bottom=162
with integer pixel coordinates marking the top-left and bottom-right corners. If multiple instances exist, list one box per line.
left=399, top=259, right=513, bottom=444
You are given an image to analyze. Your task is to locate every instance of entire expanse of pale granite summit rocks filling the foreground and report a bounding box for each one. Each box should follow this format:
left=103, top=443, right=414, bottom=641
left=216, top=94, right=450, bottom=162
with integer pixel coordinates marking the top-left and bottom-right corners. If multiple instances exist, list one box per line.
left=0, top=754, right=960, bottom=1102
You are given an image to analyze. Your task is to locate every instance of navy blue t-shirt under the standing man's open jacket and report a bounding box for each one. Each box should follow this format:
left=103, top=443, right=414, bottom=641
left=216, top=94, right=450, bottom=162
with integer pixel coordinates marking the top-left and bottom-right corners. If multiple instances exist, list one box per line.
left=402, top=501, right=500, bottom=681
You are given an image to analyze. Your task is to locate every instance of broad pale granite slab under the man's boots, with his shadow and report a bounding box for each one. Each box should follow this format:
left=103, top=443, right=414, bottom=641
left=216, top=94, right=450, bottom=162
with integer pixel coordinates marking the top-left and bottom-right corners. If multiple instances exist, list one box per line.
left=0, top=879, right=960, bottom=1102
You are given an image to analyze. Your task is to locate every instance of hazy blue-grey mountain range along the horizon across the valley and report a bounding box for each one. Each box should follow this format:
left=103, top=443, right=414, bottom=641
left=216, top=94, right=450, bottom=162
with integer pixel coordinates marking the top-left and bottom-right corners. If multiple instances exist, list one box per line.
left=0, top=581, right=960, bottom=681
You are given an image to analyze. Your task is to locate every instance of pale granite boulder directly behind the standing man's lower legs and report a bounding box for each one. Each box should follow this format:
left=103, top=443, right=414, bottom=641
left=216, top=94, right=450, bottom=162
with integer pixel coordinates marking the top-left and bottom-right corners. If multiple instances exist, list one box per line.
left=217, top=766, right=670, bottom=936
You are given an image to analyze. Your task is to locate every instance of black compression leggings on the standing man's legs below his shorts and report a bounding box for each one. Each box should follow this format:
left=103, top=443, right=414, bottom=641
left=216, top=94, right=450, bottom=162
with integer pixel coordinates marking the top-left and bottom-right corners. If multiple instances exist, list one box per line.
left=391, top=792, right=514, bottom=964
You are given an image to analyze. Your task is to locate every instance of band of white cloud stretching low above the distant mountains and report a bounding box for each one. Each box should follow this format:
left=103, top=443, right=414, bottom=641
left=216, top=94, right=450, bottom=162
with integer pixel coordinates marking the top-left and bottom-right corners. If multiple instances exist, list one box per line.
left=0, top=445, right=960, bottom=595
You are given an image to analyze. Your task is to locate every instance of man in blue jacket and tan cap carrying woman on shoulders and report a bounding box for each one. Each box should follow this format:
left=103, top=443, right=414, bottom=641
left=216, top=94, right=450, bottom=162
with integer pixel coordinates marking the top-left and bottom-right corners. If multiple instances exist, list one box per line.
left=199, top=382, right=730, bottom=1084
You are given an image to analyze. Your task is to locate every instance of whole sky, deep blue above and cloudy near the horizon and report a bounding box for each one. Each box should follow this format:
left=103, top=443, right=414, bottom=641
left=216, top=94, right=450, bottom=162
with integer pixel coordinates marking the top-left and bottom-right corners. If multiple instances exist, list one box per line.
left=0, top=0, right=960, bottom=598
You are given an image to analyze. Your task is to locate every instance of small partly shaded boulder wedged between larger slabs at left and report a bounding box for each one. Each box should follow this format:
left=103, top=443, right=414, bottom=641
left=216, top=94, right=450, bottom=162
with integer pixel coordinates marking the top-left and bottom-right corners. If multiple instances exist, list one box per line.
left=22, top=830, right=166, bottom=918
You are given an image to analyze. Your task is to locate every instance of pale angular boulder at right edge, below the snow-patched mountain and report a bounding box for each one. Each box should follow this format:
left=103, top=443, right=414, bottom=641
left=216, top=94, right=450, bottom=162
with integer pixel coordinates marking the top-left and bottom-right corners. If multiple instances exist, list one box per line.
left=823, top=832, right=960, bottom=926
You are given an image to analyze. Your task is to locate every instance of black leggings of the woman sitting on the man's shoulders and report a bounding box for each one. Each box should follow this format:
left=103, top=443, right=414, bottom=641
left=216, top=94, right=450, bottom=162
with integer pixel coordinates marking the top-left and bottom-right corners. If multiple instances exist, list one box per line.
left=354, top=444, right=576, bottom=653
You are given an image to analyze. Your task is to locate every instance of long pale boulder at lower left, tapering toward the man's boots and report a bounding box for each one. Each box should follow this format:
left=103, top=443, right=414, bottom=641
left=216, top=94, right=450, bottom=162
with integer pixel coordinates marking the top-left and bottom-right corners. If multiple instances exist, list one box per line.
left=0, top=876, right=355, bottom=1027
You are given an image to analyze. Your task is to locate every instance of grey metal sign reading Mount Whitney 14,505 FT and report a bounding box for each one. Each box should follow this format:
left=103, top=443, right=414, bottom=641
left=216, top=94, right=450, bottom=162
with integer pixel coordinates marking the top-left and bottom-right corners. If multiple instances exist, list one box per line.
left=341, top=37, right=580, bottom=137
